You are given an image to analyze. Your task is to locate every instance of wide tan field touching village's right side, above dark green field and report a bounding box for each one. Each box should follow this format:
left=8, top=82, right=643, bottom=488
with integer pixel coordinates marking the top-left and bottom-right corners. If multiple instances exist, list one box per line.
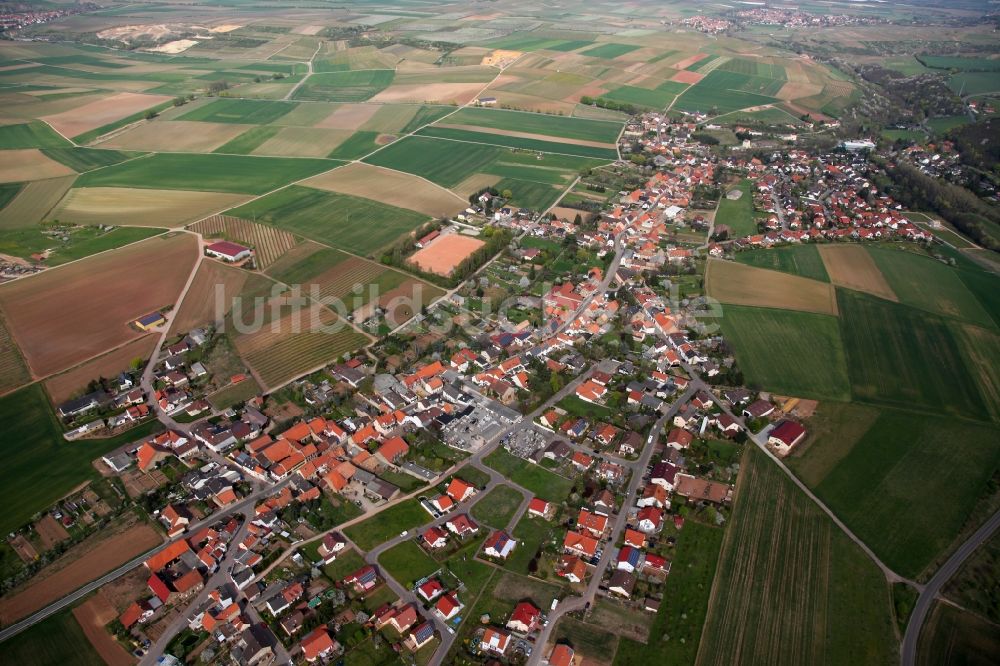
left=705, top=259, right=837, bottom=315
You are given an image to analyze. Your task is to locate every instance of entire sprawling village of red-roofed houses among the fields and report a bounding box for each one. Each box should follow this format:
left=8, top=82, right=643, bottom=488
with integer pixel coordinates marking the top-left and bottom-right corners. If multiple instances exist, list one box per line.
left=1, top=109, right=976, bottom=666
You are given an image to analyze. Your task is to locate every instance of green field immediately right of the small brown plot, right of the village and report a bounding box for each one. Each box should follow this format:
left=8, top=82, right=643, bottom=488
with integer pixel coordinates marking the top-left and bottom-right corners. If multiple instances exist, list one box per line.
left=867, top=247, right=1000, bottom=326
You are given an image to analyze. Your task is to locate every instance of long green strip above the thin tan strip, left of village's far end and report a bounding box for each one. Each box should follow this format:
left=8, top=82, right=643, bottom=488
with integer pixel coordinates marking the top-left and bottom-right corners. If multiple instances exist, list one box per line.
left=446, top=108, right=623, bottom=143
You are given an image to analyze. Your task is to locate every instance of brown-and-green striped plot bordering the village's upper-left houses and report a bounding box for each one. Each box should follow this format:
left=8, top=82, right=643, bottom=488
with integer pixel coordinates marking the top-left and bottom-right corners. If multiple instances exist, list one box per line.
left=235, top=305, right=368, bottom=388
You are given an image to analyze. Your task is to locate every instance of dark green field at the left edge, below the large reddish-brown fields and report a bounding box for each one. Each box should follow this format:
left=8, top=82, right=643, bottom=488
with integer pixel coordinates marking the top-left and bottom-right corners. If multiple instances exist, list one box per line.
left=0, top=384, right=159, bottom=534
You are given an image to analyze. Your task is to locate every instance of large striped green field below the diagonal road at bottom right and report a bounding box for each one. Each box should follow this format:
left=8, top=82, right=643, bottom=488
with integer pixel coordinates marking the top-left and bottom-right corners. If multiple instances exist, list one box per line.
left=696, top=447, right=897, bottom=666
